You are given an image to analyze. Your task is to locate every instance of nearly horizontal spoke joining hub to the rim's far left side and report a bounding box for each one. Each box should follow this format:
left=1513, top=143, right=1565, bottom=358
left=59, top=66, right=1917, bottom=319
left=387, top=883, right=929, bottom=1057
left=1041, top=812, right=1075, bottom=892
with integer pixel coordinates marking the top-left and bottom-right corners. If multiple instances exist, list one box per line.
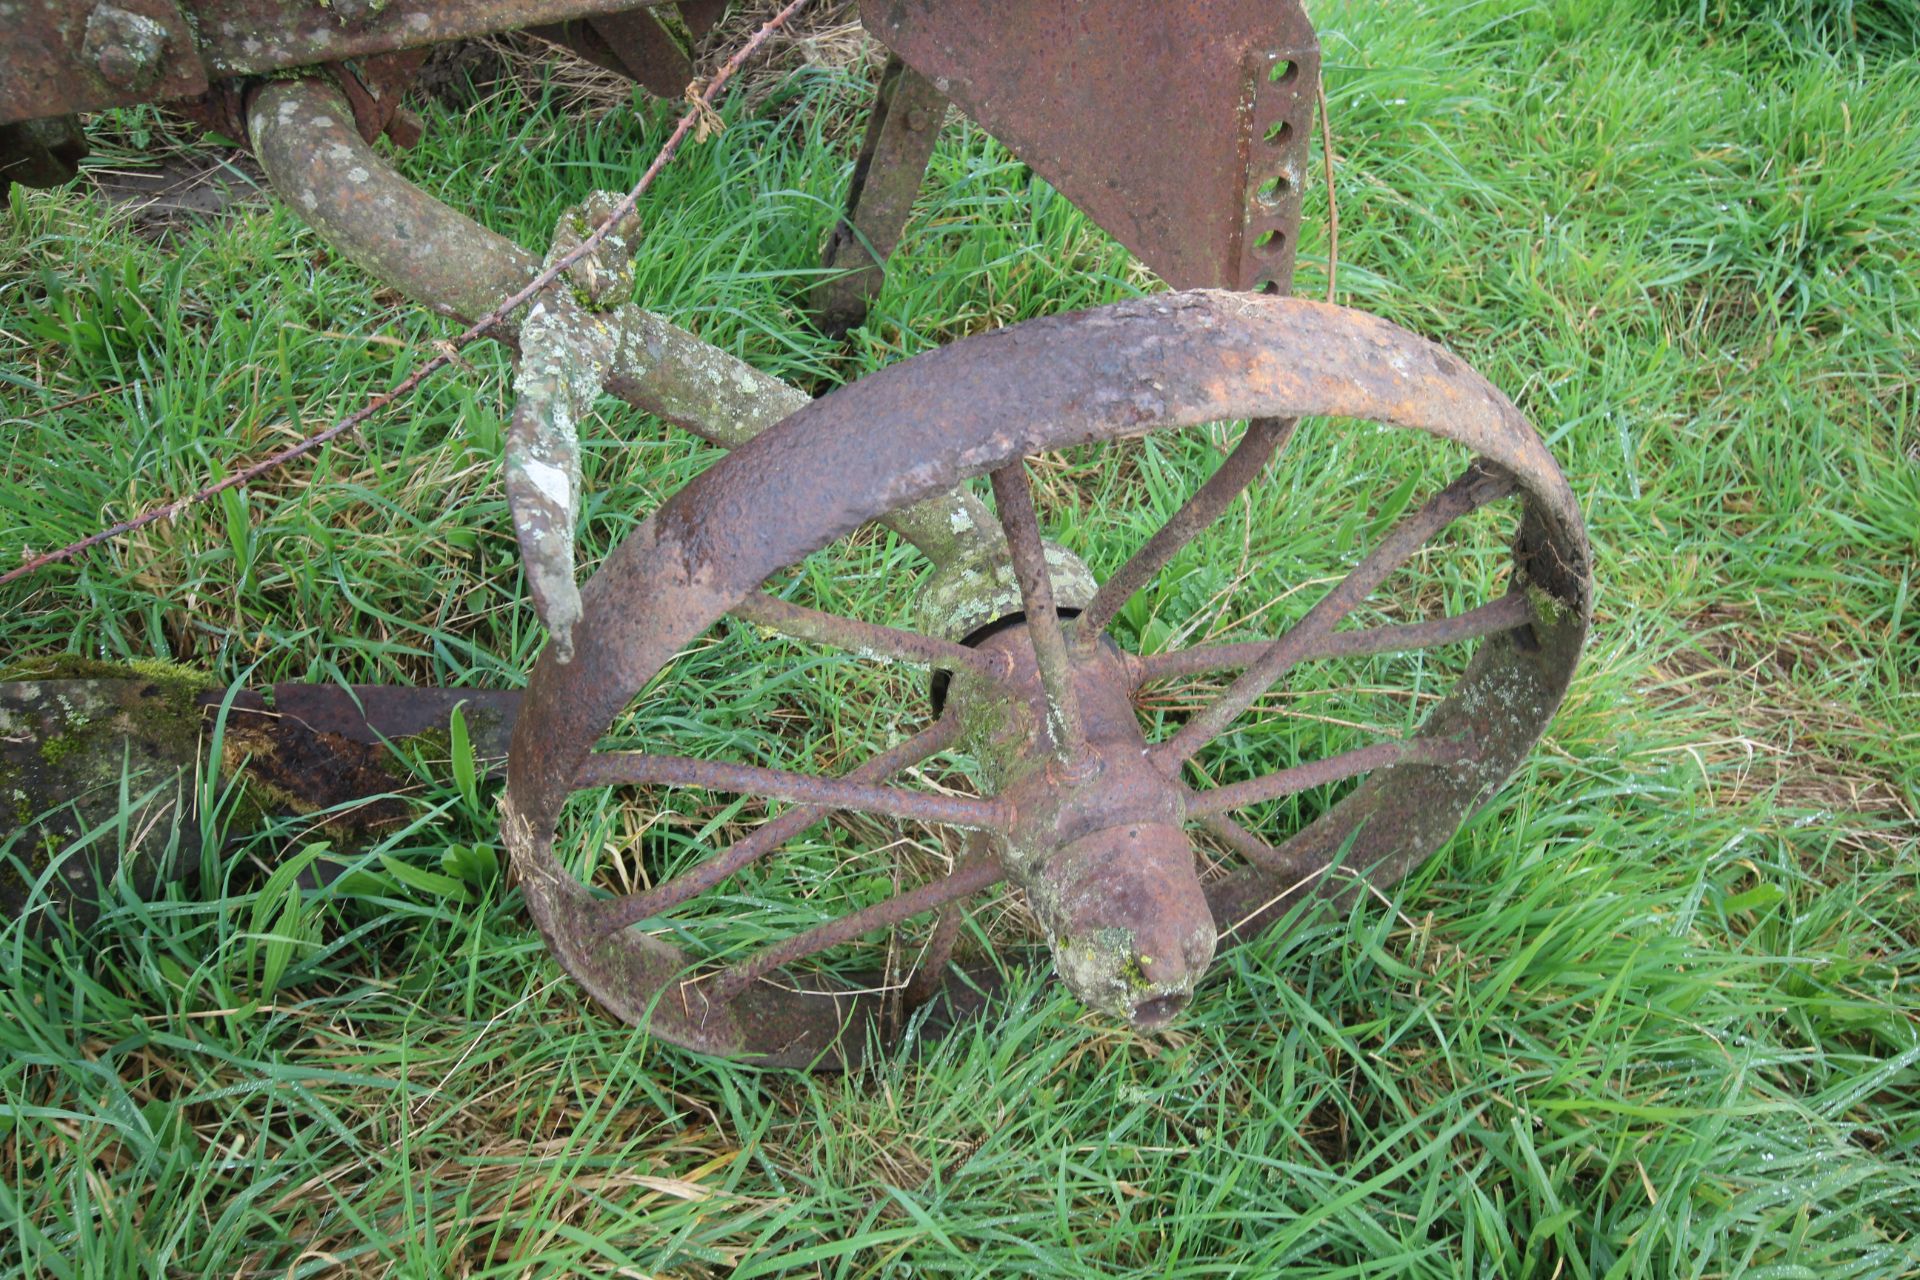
left=574, top=750, right=1006, bottom=831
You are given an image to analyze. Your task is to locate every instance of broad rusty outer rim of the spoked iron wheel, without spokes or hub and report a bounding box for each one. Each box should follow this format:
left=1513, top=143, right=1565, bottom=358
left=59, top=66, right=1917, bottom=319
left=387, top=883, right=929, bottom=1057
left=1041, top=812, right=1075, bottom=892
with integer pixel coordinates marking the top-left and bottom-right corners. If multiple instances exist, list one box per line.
left=503, top=292, right=1590, bottom=1067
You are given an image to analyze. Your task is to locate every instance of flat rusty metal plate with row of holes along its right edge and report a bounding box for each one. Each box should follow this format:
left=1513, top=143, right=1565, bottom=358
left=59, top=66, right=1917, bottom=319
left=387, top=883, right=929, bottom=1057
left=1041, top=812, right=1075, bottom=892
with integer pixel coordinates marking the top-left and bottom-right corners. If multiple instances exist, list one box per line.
left=860, top=0, right=1319, bottom=292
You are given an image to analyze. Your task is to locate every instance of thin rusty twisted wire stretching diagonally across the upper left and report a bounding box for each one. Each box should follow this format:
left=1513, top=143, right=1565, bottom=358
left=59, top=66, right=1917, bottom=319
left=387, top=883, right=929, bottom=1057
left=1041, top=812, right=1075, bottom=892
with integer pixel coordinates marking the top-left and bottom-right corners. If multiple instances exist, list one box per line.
left=0, top=0, right=810, bottom=587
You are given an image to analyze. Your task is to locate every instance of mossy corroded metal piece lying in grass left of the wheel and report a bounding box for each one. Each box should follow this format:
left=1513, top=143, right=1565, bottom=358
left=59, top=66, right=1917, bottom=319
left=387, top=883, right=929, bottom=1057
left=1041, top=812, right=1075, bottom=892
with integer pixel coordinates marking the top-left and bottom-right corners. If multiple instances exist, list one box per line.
left=0, top=671, right=520, bottom=929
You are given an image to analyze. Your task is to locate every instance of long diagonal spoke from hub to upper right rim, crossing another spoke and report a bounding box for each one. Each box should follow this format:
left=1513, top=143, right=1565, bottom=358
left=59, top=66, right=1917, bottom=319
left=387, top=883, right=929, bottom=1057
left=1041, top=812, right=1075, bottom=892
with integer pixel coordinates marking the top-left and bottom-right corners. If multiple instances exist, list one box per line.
left=1152, top=462, right=1515, bottom=768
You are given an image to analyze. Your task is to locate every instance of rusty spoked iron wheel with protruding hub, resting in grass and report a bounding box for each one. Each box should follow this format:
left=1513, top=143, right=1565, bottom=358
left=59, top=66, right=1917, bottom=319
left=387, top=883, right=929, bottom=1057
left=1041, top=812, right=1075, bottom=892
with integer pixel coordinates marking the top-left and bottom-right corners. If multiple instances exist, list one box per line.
left=503, top=292, right=1590, bottom=1069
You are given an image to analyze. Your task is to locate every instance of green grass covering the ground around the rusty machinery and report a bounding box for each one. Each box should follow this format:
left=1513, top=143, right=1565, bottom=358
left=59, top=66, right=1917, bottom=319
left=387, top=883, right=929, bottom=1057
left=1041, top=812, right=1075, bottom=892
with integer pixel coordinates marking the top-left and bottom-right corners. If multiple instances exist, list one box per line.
left=0, top=0, right=1920, bottom=1280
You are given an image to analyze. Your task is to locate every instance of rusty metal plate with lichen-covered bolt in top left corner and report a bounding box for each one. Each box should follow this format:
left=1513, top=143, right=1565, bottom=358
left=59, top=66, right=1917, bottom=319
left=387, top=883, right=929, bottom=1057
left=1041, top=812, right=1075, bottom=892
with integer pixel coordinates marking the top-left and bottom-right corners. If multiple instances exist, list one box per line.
left=0, top=0, right=207, bottom=123
